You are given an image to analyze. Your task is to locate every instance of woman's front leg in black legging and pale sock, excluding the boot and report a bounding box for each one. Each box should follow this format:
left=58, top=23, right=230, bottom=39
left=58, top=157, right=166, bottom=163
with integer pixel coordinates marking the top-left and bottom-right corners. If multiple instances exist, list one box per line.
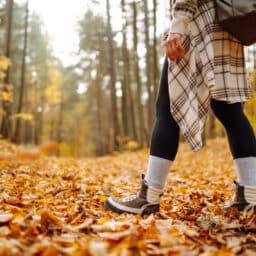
left=145, top=59, right=179, bottom=189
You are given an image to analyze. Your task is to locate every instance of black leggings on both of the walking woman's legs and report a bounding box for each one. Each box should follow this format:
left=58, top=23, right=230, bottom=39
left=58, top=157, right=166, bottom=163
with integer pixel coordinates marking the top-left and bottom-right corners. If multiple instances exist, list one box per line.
left=150, top=59, right=256, bottom=161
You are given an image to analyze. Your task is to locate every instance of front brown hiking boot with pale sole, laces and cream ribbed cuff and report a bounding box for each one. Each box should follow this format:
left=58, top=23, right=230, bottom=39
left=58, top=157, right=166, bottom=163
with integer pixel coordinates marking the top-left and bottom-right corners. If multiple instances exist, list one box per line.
left=104, top=175, right=163, bottom=215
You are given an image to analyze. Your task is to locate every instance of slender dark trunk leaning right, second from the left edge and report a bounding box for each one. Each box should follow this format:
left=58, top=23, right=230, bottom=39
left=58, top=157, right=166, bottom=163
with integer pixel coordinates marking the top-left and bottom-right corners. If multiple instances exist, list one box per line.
left=14, top=0, right=29, bottom=143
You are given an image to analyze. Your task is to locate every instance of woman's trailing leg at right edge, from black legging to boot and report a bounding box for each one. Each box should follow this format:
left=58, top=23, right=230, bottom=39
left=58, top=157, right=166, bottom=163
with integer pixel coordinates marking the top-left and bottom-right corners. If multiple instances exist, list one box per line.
left=211, top=100, right=256, bottom=210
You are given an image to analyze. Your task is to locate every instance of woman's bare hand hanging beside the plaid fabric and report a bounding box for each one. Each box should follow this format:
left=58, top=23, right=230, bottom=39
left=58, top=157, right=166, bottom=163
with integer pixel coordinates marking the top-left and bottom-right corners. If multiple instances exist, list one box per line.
left=164, top=33, right=185, bottom=60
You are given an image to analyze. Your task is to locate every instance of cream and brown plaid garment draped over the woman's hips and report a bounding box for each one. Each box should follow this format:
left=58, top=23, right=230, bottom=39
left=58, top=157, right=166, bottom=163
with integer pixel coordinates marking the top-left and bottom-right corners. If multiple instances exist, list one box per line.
left=165, top=0, right=250, bottom=151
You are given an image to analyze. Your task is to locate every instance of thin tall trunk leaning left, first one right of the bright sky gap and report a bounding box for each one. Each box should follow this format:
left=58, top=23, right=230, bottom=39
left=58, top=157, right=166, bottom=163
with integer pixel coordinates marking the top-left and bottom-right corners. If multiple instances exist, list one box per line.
left=106, top=0, right=120, bottom=150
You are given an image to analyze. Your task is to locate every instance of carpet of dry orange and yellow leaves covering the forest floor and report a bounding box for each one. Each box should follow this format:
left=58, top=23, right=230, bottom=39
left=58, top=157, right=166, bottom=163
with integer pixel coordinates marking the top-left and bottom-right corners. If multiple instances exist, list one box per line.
left=0, top=139, right=256, bottom=256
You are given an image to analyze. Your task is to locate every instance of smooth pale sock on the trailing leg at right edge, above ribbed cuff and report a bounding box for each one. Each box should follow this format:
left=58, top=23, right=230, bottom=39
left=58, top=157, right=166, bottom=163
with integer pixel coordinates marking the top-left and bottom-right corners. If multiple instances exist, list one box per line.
left=234, top=157, right=256, bottom=186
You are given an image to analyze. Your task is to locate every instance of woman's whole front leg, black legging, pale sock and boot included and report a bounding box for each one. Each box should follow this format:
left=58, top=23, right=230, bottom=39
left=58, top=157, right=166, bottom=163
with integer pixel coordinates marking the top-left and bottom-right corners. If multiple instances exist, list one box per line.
left=105, top=59, right=179, bottom=215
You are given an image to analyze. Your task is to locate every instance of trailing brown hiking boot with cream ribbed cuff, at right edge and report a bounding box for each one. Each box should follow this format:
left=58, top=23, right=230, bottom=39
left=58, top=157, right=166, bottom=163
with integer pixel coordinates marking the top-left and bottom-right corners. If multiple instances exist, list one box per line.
left=223, top=181, right=256, bottom=213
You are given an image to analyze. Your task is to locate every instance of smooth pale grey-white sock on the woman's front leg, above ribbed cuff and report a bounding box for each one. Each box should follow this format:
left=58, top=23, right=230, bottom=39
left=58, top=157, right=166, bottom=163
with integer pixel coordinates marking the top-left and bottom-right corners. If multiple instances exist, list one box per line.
left=145, top=155, right=172, bottom=189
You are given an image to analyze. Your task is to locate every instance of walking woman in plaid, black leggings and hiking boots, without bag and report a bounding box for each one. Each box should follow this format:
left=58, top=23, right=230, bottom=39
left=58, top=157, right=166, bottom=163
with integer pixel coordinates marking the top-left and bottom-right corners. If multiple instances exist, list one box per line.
left=105, top=0, right=256, bottom=215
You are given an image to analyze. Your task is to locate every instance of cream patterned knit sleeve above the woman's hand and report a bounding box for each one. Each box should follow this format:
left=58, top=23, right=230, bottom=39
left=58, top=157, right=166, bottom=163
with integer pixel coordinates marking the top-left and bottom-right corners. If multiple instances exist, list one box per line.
left=169, top=0, right=197, bottom=34
